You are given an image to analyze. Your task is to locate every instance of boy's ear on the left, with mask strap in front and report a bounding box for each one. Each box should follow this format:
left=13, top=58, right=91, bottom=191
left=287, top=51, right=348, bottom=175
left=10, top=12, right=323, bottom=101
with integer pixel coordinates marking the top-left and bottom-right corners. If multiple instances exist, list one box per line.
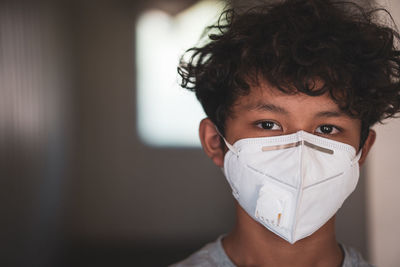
left=199, top=118, right=224, bottom=167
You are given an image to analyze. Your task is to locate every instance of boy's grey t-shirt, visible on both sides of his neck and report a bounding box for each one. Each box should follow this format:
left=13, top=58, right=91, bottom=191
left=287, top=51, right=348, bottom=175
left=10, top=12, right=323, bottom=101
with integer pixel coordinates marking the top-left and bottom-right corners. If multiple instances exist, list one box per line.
left=170, top=236, right=373, bottom=267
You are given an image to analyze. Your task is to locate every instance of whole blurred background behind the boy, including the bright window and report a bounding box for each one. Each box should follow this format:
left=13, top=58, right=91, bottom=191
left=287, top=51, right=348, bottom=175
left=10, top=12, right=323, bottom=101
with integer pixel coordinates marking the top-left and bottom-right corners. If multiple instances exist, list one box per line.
left=0, top=0, right=400, bottom=267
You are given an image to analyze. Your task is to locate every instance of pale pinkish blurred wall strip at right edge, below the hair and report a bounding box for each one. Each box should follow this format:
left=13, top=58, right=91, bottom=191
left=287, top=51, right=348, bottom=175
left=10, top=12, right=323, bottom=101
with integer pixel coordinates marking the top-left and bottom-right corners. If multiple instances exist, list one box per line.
left=367, top=120, right=400, bottom=267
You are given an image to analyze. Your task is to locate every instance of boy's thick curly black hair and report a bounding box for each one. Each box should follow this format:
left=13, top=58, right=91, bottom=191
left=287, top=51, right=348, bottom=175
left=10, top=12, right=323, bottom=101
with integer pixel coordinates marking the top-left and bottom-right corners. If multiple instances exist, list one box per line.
left=178, top=0, right=400, bottom=147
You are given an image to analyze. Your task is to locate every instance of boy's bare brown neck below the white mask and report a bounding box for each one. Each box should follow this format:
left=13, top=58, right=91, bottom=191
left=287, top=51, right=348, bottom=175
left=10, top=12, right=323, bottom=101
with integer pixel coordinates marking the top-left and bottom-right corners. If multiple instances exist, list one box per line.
left=222, top=204, right=343, bottom=267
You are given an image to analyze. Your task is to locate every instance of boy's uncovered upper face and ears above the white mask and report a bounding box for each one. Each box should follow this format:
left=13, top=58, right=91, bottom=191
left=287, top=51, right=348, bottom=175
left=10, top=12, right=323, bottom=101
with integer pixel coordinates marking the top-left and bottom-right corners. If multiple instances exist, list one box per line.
left=200, top=83, right=375, bottom=167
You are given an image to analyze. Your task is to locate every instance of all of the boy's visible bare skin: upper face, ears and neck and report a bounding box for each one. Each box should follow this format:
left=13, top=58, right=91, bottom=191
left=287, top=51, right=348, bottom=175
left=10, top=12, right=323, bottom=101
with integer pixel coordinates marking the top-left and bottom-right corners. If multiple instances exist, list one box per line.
left=199, top=83, right=375, bottom=267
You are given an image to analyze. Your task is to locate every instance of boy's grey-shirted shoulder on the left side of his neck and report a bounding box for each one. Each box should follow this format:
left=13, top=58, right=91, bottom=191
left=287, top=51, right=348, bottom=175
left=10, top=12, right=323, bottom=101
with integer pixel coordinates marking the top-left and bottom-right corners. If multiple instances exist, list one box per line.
left=170, top=236, right=235, bottom=267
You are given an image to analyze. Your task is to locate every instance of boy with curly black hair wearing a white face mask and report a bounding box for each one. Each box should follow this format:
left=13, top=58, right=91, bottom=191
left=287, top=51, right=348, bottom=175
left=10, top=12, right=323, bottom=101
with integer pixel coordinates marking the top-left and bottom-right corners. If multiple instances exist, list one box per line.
left=171, top=0, right=400, bottom=267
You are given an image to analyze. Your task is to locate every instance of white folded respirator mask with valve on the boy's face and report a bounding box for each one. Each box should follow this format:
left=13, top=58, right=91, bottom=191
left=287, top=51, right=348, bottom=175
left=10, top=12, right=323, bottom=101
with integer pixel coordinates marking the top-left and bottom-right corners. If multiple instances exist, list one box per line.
left=220, top=131, right=361, bottom=244
